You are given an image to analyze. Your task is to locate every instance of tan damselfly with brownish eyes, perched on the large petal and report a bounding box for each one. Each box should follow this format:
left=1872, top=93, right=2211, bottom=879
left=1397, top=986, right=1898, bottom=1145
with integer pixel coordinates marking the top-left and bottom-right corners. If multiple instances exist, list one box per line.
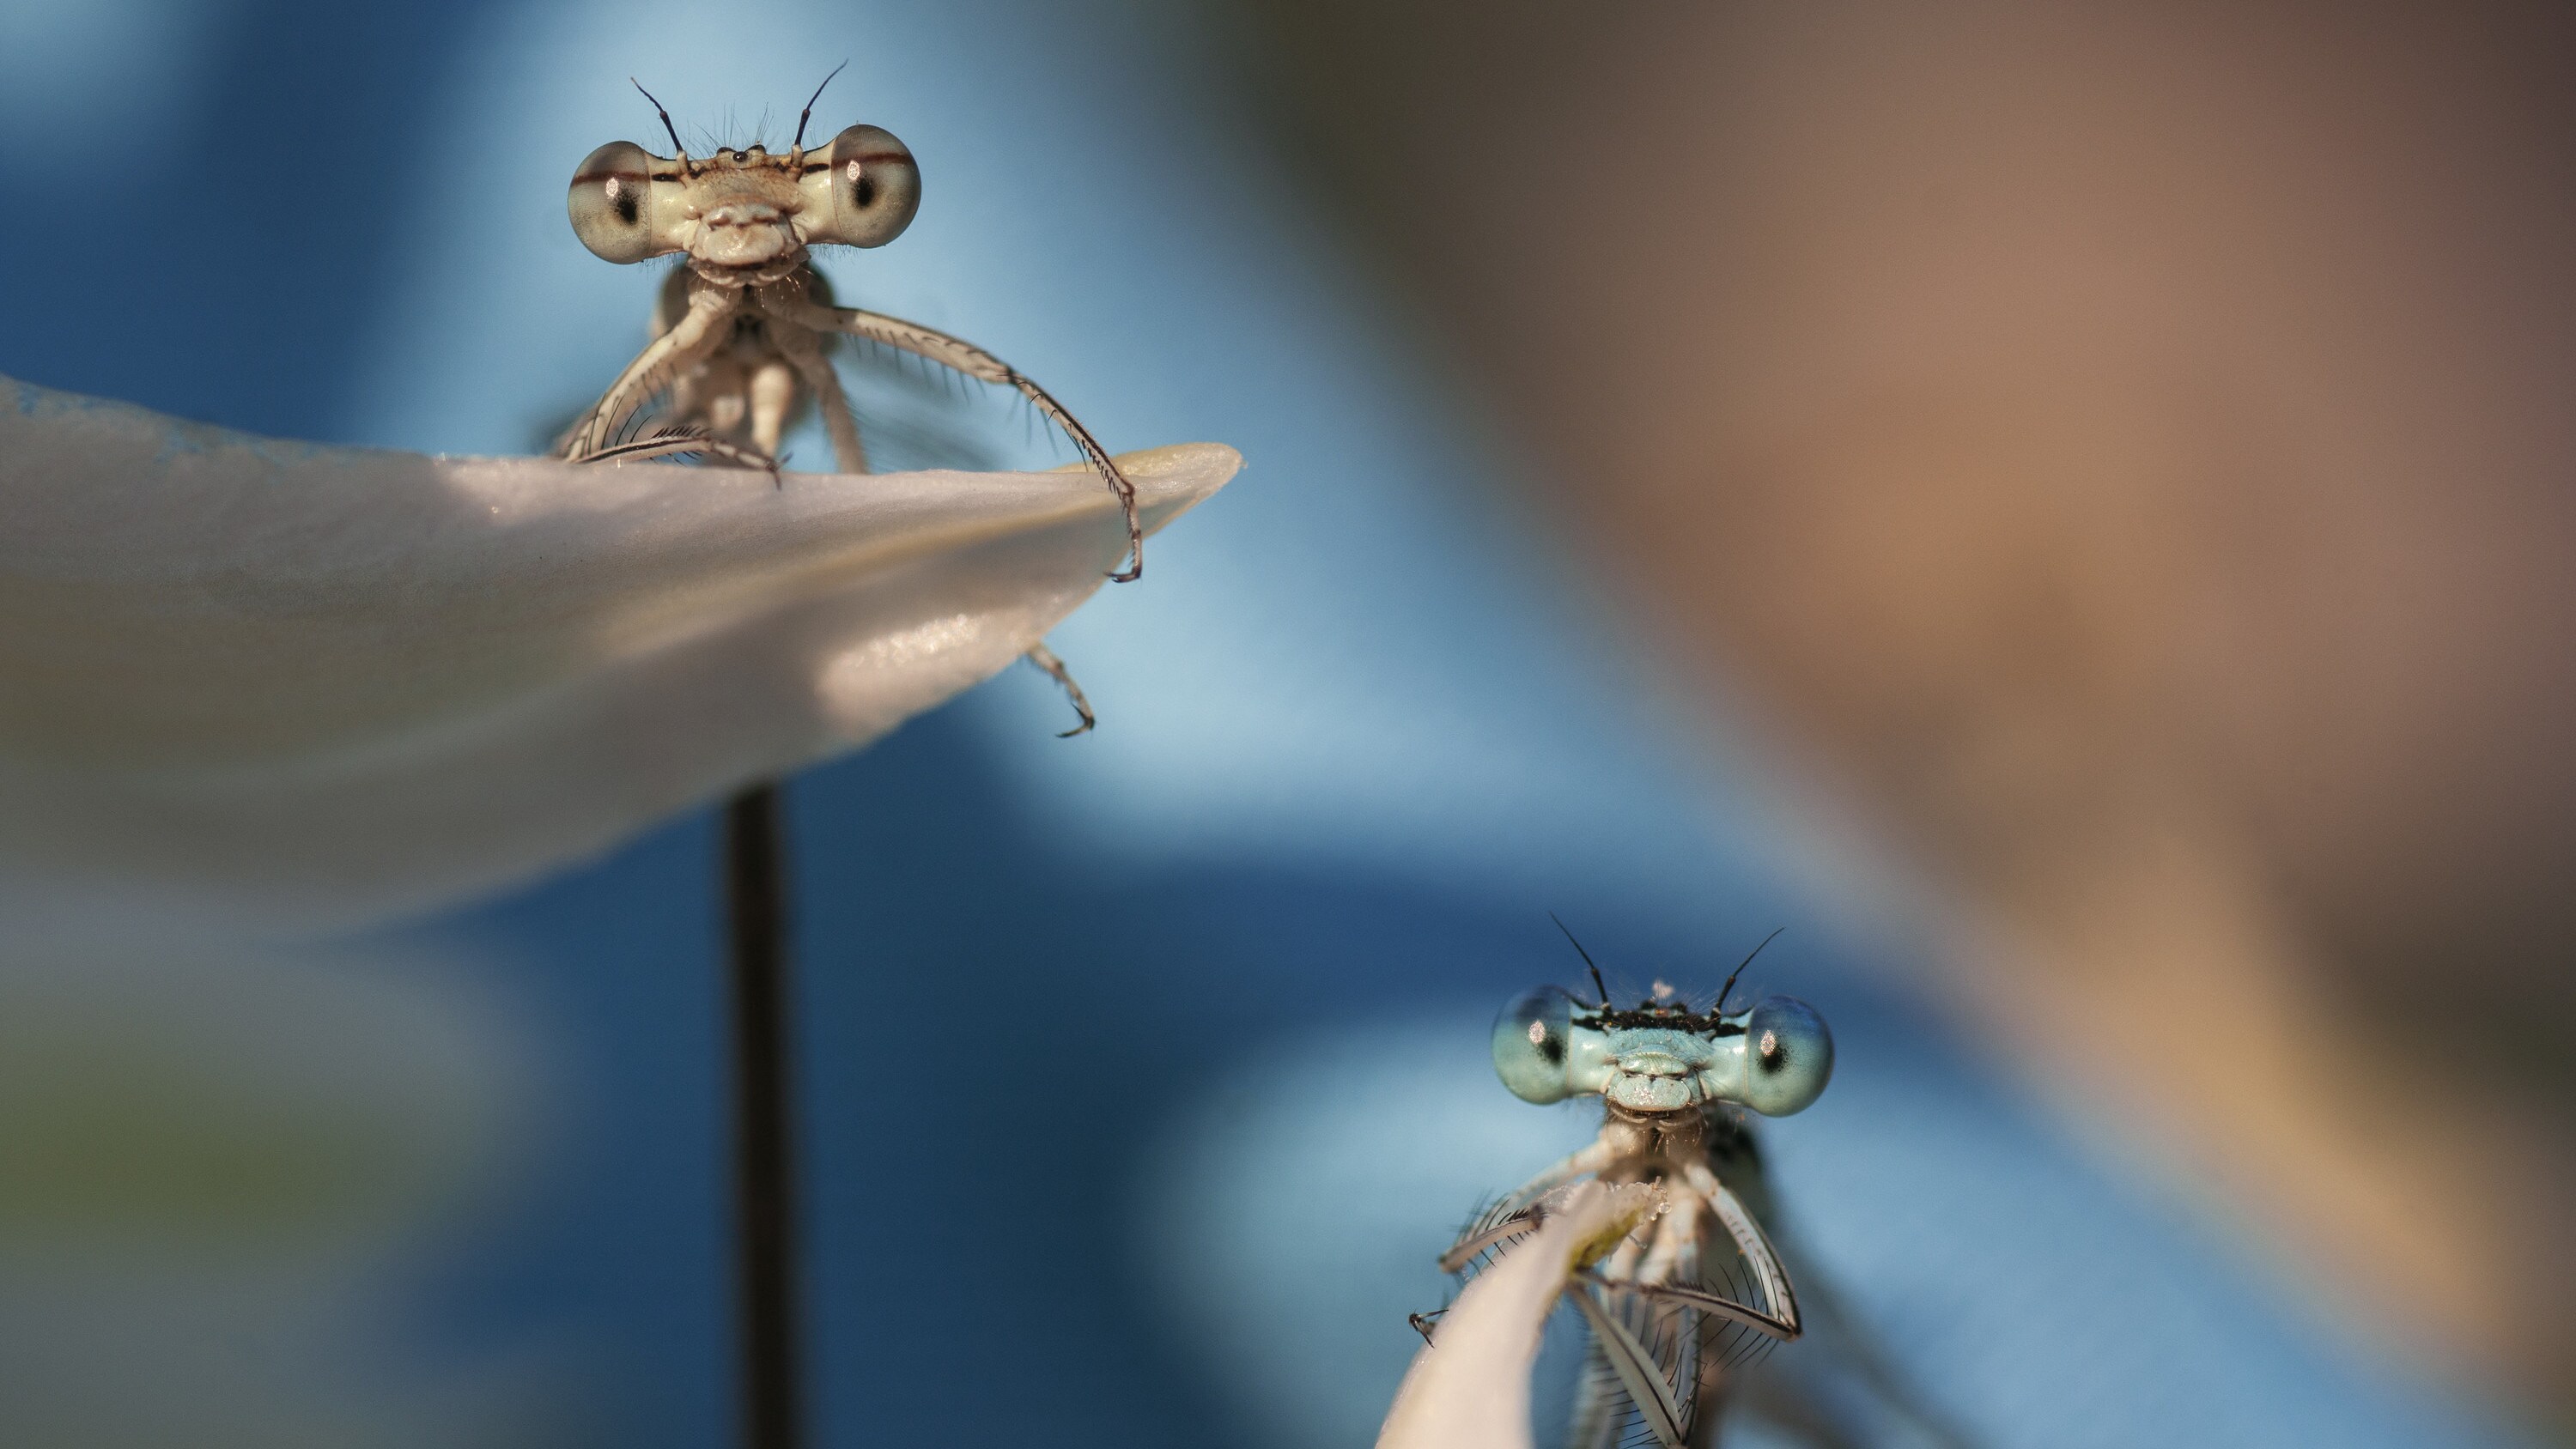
left=556, top=70, right=1144, bottom=733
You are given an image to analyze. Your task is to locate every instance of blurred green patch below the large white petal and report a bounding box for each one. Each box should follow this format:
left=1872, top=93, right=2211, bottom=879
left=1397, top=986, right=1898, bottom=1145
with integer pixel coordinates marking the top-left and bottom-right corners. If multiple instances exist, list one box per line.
left=0, top=962, right=492, bottom=1261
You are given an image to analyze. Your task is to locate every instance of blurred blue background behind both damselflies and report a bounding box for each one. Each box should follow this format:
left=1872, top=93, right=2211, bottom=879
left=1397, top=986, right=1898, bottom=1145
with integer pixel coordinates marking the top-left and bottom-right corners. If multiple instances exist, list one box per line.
left=0, top=0, right=2535, bottom=1449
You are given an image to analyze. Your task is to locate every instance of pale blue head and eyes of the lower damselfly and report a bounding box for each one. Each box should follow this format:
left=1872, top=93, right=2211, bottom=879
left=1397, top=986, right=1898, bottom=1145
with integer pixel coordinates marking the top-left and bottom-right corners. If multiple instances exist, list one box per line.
left=1494, top=937, right=1834, bottom=1117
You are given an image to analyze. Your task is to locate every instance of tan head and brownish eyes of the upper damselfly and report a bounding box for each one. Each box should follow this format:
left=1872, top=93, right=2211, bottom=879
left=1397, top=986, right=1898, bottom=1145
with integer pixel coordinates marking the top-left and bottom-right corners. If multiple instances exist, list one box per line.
left=567, top=88, right=922, bottom=278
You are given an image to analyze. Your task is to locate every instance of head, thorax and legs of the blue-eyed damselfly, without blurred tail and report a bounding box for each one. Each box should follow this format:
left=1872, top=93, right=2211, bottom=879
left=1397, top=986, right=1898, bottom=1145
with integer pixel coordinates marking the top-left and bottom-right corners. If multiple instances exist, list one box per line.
left=1417, top=931, right=1834, bottom=1449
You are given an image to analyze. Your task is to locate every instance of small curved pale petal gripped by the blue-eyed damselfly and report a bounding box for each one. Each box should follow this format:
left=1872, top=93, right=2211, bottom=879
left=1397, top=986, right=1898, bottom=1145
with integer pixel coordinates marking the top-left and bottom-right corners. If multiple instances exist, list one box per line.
left=1378, top=1181, right=1656, bottom=1449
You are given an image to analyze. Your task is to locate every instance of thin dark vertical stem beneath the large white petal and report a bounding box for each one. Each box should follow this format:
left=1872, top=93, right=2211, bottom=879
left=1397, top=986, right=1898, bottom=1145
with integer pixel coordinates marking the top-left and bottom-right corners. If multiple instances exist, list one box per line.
left=724, top=785, right=804, bottom=1449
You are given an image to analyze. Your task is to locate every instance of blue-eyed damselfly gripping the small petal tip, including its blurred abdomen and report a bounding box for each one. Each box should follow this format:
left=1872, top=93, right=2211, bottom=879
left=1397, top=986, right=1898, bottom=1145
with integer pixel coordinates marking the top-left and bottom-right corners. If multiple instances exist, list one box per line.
left=1414, top=921, right=1973, bottom=1449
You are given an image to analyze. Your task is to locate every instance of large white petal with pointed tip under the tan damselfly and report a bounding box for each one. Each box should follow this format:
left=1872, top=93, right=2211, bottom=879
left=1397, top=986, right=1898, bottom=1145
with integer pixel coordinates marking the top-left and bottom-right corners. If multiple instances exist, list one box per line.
left=0, top=379, right=1242, bottom=929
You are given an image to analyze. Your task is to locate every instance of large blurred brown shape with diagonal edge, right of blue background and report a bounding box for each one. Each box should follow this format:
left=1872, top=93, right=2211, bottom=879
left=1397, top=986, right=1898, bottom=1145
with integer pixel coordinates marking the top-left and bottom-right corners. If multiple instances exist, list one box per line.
left=1221, top=0, right=2576, bottom=1416
